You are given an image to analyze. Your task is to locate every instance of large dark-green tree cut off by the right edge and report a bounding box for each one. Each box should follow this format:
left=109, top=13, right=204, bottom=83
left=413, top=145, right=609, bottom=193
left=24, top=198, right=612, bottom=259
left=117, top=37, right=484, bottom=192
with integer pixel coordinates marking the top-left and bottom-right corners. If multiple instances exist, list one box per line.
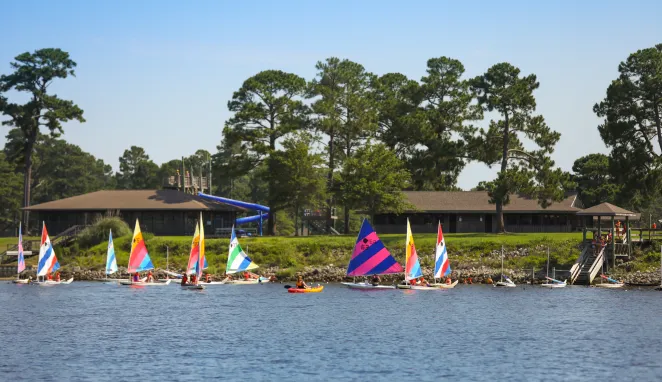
left=593, top=44, right=662, bottom=209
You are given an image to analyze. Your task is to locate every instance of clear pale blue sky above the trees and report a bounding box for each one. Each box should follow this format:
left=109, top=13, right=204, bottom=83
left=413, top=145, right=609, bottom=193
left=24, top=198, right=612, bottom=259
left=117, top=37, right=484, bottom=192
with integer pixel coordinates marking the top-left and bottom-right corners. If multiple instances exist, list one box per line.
left=0, top=0, right=662, bottom=190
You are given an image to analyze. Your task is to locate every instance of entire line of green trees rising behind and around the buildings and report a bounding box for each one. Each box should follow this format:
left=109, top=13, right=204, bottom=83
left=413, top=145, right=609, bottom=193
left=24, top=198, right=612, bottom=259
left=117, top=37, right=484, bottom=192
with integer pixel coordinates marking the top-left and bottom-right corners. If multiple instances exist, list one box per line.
left=0, top=45, right=662, bottom=234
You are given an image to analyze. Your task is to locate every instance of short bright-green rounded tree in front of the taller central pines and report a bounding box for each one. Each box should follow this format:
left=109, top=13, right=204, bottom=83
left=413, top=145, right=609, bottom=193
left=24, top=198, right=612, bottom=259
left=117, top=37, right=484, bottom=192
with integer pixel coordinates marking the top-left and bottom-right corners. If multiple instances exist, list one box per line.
left=341, top=144, right=411, bottom=221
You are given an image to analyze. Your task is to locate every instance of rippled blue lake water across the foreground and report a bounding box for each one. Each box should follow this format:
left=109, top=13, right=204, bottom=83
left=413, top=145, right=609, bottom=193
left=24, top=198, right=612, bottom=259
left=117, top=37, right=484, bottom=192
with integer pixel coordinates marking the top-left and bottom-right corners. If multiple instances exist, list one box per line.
left=0, top=282, right=662, bottom=381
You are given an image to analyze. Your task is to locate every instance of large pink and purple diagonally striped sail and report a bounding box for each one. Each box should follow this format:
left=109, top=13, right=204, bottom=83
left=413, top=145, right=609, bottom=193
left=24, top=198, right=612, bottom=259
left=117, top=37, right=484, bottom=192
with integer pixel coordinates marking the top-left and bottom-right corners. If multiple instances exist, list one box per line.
left=347, top=219, right=402, bottom=276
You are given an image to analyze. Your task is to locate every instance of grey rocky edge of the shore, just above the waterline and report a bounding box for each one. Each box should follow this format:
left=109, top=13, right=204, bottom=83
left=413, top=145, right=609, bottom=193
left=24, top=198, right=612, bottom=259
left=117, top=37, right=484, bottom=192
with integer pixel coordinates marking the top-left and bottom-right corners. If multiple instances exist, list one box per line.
left=10, top=264, right=661, bottom=285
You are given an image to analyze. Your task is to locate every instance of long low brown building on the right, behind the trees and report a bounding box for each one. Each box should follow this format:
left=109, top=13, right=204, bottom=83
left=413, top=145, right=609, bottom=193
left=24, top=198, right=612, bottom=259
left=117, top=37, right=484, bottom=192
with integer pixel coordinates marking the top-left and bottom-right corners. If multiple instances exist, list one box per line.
left=374, top=191, right=585, bottom=233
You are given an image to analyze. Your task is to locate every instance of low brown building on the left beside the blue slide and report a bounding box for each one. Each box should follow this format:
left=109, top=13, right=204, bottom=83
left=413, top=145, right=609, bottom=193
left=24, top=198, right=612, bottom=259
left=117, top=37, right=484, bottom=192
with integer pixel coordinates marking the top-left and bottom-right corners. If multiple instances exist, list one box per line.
left=26, top=190, right=248, bottom=235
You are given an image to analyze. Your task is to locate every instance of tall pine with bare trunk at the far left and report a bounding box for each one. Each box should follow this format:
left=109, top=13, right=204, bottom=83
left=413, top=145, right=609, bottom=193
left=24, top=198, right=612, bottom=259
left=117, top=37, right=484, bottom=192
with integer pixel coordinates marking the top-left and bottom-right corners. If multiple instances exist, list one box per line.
left=0, top=48, right=85, bottom=227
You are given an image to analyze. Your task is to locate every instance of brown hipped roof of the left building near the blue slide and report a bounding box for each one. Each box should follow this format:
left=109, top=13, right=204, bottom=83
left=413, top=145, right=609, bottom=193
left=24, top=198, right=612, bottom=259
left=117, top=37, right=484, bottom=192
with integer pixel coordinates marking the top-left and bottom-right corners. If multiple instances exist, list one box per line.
left=25, top=190, right=248, bottom=211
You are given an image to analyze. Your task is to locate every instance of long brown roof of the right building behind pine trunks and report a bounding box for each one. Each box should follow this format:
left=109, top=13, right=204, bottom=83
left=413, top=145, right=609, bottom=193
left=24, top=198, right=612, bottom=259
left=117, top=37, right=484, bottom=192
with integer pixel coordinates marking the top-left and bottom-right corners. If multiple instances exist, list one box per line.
left=403, top=191, right=581, bottom=213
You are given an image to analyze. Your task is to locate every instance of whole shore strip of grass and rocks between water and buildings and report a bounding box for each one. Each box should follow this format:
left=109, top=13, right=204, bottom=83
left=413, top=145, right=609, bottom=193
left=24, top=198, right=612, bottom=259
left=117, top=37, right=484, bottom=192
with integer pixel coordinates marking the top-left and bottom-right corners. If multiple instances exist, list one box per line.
left=2, top=232, right=660, bottom=284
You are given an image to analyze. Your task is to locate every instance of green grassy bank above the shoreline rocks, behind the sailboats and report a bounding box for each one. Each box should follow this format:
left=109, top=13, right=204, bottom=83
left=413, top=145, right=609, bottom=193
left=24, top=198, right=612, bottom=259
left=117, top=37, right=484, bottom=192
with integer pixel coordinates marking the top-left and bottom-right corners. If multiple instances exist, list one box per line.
left=10, top=233, right=581, bottom=275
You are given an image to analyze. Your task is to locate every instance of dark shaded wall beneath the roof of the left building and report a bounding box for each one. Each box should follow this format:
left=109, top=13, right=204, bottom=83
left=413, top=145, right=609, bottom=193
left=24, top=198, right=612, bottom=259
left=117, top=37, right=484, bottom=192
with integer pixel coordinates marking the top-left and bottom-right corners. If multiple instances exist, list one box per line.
left=31, top=210, right=236, bottom=236
